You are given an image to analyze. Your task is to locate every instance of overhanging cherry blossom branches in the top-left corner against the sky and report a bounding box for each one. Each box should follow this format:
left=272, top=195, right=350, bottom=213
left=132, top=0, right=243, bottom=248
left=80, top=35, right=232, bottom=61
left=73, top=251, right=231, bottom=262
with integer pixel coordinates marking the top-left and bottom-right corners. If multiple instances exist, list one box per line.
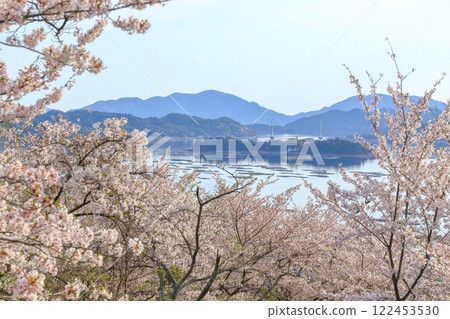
left=0, top=0, right=166, bottom=122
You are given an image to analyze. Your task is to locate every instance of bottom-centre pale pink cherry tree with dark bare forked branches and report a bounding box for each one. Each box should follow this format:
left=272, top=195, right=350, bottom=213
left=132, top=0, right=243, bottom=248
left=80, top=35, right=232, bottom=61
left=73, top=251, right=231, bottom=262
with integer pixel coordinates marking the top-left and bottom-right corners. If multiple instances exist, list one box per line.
left=121, top=176, right=331, bottom=300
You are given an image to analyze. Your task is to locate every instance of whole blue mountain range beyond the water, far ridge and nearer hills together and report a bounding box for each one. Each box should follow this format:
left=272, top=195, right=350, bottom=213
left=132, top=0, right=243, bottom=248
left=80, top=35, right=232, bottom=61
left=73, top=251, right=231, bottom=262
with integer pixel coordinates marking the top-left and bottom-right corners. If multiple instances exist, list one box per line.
left=36, top=90, right=445, bottom=137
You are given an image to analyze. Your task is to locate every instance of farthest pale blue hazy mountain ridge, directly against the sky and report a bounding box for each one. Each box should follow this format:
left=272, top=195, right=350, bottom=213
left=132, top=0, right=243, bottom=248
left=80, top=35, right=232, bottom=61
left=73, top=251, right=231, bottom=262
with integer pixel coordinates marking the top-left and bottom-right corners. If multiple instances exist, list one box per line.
left=81, top=90, right=444, bottom=126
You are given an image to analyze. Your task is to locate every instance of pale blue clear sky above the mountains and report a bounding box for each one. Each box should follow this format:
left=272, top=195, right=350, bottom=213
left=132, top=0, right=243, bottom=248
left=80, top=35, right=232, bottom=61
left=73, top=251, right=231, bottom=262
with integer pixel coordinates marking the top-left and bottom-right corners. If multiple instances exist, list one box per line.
left=7, top=0, right=450, bottom=114
